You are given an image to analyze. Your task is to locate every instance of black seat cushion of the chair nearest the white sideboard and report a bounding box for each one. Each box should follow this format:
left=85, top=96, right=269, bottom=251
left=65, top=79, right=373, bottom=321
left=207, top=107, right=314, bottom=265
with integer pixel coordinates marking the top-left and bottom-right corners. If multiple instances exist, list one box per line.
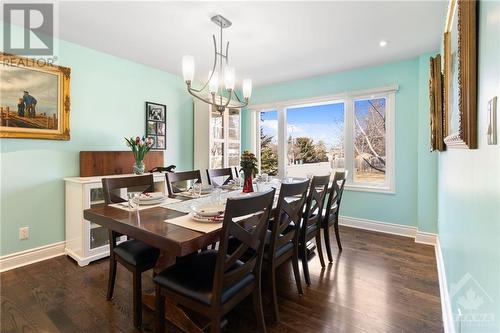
left=114, top=239, right=160, bottom=267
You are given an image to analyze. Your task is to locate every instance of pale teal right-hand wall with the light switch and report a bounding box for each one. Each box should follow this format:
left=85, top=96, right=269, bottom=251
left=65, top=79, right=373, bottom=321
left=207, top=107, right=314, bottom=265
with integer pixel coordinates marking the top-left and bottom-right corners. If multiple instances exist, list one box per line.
left=438, top=1, right=500, bottom=333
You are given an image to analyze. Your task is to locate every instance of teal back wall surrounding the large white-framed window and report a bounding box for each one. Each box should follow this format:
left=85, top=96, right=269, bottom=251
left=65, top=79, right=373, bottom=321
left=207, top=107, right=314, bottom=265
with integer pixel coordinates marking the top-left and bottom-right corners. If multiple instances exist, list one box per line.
left=244, top=56, right=437, bottom=232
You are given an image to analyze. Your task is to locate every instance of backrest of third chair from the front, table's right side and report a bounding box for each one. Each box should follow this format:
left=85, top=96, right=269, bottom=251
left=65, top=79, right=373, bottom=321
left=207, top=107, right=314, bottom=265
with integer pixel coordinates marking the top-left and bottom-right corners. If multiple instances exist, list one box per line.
left=301, top=175, right=330, bottom=235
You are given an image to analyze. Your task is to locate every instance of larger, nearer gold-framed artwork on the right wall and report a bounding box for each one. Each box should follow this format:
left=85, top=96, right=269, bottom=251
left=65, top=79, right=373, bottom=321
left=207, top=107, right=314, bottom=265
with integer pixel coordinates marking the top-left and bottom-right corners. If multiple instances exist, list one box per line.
left=444, top=0, right=478, bottom=149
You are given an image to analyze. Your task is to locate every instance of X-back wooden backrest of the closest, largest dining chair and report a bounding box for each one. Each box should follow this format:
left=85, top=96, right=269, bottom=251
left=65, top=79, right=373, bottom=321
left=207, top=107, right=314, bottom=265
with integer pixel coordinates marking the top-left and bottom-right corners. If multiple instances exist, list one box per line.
left=213, top=189, right=275, bottom=304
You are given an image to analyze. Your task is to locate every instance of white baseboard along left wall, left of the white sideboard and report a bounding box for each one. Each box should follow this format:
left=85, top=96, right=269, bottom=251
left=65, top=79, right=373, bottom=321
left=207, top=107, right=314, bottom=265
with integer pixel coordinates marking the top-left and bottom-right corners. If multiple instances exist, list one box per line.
left=0, top=241, right=66, bottom=272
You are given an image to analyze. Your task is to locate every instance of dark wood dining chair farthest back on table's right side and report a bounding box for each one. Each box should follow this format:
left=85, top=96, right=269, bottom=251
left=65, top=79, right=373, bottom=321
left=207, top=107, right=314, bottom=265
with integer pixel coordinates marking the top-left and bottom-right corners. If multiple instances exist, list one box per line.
left=321, top=171, right=347, bottom=262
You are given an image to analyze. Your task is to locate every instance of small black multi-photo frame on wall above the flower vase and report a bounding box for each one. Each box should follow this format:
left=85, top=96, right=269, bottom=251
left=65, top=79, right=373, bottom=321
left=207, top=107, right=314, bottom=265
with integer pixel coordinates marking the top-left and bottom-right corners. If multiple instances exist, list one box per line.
left=146, top=102, right=167, bottom=150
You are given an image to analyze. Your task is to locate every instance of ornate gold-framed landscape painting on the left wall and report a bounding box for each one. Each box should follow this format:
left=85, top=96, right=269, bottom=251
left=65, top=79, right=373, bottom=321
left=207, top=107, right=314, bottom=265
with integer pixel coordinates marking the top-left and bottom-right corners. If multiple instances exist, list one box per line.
left=0, top=53, right=71, bottom=140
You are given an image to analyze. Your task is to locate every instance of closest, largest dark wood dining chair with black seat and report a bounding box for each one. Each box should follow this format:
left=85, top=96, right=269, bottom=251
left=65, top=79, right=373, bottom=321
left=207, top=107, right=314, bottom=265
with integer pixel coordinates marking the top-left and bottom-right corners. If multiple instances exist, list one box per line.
left=154, top=189, right=275, bottom=333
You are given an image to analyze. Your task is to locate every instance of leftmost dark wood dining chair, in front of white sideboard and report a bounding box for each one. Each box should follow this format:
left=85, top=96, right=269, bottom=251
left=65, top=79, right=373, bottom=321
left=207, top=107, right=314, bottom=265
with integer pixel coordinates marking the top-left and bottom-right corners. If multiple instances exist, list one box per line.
left=102, top=175, right=160, bottom=327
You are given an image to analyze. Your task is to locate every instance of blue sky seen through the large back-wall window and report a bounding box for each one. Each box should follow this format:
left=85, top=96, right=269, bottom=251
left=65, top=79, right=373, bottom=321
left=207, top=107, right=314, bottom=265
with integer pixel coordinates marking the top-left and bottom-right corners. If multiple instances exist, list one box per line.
left=261, top=98, right=385, bottom=148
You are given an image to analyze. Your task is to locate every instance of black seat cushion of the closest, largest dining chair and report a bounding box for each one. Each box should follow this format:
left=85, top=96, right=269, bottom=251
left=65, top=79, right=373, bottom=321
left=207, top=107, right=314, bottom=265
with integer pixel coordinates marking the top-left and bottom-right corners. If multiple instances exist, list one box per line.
left=154, top=250, right=255, bottom=305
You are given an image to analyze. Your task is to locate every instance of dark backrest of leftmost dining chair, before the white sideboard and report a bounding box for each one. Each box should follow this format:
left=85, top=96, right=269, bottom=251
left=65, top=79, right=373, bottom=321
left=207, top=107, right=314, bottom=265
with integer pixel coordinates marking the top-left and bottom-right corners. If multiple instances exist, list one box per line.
left=102, top=174, right=154, bottom=205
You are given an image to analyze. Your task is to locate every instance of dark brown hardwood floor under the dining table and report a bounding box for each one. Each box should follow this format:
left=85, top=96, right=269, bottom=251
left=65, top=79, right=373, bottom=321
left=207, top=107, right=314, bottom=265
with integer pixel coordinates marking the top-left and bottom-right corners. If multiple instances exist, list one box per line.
left=1, top=227, right=443, bottom=333
